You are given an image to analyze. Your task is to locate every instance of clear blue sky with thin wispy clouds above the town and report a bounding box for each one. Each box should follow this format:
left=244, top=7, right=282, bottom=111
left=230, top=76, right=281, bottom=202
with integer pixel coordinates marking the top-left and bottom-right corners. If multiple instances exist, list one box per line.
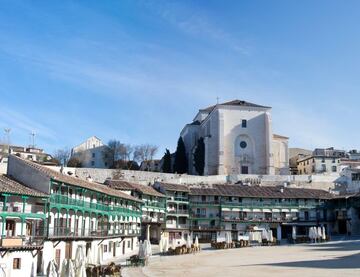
left=0, top=0, right=360, bottom=156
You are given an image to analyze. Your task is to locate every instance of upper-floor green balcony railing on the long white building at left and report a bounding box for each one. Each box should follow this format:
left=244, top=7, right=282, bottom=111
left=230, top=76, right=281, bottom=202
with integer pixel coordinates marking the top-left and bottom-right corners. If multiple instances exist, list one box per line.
left=50, top=194, right=141, bottom=216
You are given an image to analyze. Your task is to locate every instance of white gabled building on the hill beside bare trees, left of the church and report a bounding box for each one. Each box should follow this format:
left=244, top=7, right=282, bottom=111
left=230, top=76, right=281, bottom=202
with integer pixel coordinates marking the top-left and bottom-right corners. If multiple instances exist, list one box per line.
left=71, top=136, right=113, bottom=168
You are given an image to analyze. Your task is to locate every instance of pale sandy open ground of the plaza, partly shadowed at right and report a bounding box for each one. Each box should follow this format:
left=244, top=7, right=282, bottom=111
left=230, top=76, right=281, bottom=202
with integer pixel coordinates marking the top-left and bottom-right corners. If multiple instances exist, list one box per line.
left=123, top=240, right=360, bottom=277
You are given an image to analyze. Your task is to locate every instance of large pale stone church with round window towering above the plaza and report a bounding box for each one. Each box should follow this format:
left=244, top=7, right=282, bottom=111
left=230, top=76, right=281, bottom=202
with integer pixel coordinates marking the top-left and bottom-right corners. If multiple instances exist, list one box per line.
left=180, top=100, right=289, bottom=175
